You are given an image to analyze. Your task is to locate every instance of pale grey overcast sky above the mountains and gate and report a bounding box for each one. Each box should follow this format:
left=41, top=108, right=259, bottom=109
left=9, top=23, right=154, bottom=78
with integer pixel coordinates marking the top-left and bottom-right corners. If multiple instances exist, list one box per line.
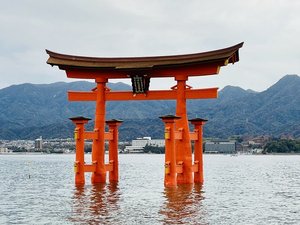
left=0, top=0, right=300, bottom=91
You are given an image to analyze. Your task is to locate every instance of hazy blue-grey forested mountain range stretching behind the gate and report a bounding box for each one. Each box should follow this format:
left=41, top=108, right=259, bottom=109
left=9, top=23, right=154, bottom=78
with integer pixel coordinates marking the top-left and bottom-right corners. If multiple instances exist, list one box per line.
left=0, top=75, right=300, bottom=140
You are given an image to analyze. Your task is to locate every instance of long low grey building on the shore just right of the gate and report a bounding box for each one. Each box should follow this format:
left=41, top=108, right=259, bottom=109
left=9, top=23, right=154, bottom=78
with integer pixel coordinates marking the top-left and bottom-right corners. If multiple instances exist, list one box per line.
left=204, top=140, right=236, bottom=154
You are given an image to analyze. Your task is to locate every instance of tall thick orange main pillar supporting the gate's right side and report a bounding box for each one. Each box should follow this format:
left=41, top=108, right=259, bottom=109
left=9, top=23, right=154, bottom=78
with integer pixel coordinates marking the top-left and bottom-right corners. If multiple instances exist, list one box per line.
left=175, top=76, right=193, bottom=184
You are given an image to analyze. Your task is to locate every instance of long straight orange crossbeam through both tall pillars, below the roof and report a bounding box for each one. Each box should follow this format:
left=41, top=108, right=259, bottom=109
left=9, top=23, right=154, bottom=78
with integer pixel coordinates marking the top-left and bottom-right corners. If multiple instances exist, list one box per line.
left=68, top=88, right=218, bottom=101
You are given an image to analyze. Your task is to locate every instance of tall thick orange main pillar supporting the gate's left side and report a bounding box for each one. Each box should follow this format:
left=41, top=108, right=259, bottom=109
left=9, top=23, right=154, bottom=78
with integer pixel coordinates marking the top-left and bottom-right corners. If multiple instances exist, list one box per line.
left=91, top=78, right=107, bottom=184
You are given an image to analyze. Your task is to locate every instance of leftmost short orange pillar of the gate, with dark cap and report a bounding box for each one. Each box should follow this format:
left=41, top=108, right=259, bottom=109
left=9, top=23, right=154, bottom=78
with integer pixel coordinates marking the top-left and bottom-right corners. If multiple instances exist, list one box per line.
left=70, top=117, right=90, bottom=184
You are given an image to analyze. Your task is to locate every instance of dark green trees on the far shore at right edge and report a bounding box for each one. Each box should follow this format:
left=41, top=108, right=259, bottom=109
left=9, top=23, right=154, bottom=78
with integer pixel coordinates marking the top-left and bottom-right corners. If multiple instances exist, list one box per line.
left=264, top=139, right=300, bottom=153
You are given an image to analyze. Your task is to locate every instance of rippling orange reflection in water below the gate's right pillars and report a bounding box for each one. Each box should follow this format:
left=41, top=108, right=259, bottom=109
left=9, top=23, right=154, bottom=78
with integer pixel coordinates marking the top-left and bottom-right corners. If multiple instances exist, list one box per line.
left=159, top=184, right=208, bottom=224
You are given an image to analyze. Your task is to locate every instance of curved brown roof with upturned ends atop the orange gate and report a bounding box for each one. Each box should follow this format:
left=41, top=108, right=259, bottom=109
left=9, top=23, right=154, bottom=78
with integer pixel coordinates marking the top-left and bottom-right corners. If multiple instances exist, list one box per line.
left=46, top=42, right=243, bottom=77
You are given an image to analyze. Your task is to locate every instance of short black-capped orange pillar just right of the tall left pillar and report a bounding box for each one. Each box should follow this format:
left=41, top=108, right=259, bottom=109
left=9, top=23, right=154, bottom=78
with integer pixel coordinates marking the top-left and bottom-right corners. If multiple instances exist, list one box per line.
left=106, top=119, right=123, bottom=182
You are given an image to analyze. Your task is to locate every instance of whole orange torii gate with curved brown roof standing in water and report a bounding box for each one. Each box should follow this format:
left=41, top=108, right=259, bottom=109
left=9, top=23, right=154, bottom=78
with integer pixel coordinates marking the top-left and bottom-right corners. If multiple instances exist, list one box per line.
left=46, top=43, right=243, bottom=186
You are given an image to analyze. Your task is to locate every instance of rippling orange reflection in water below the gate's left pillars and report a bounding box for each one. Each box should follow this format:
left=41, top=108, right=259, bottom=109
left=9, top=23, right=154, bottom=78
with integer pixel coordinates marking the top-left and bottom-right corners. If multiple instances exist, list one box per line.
left=69, top=183, right=120, bottom=224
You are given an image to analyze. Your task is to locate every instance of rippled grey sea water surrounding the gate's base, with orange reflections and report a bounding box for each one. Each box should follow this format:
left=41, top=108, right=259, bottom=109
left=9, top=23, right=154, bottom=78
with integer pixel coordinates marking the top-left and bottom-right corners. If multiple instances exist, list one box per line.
left=0, top=154, right=300, bottom=225
